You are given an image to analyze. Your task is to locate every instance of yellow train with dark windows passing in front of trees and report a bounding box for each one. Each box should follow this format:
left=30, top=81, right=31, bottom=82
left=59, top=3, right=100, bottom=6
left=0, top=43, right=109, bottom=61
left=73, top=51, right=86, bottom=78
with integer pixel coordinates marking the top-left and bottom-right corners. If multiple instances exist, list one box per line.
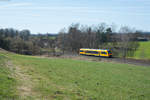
left=79, top=48, right=112, bottom=57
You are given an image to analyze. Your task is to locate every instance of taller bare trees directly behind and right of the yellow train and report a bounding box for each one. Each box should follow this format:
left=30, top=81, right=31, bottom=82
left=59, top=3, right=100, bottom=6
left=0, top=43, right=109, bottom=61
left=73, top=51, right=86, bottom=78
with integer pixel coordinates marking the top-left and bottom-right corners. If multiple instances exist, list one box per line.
left=57, top=23, right=142, bottom=58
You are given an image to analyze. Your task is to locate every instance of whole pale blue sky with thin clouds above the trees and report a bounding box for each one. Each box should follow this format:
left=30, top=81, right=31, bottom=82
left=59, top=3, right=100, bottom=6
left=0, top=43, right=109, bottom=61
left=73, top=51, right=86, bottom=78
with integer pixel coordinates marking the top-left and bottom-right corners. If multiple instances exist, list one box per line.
left=0, top=0, right=150, bottom=34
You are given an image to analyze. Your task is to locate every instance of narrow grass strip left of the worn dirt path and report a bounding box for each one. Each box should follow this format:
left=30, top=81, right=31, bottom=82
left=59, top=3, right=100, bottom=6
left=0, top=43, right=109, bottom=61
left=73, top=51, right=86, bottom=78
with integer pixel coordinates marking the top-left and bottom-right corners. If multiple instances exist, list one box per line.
left=0, top=54, right=18, bottom=100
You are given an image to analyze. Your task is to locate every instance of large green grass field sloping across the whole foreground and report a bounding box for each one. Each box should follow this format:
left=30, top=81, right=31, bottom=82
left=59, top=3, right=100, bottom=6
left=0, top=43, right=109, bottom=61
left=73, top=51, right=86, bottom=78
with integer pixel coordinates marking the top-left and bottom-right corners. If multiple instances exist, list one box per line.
left=0, top=53, right=150, bottom=100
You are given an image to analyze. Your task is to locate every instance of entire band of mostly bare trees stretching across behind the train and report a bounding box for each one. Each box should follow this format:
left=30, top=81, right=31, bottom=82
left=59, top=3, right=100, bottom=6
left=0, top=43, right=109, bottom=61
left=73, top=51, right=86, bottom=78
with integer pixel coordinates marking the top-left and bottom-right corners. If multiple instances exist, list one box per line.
left=0, top=23, right=148, bottom=57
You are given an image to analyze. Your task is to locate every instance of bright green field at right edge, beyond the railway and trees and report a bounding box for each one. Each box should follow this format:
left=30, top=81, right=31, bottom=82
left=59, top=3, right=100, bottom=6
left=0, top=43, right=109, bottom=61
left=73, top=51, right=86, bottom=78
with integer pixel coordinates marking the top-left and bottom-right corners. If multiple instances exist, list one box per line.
left=134, top=42, right=150, bottom=59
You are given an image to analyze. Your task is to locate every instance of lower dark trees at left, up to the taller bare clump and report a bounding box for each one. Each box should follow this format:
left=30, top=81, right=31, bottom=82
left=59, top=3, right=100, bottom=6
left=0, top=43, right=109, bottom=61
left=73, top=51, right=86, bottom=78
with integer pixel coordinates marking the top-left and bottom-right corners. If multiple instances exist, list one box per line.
left=0, top=28, right=55, bottom=55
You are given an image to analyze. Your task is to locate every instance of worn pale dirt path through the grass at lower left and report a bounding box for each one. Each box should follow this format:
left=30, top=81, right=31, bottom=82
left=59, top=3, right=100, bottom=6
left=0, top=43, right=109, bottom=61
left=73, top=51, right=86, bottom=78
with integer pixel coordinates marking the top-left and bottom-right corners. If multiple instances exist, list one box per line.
left=7, top=61, right=40, bottom=100
